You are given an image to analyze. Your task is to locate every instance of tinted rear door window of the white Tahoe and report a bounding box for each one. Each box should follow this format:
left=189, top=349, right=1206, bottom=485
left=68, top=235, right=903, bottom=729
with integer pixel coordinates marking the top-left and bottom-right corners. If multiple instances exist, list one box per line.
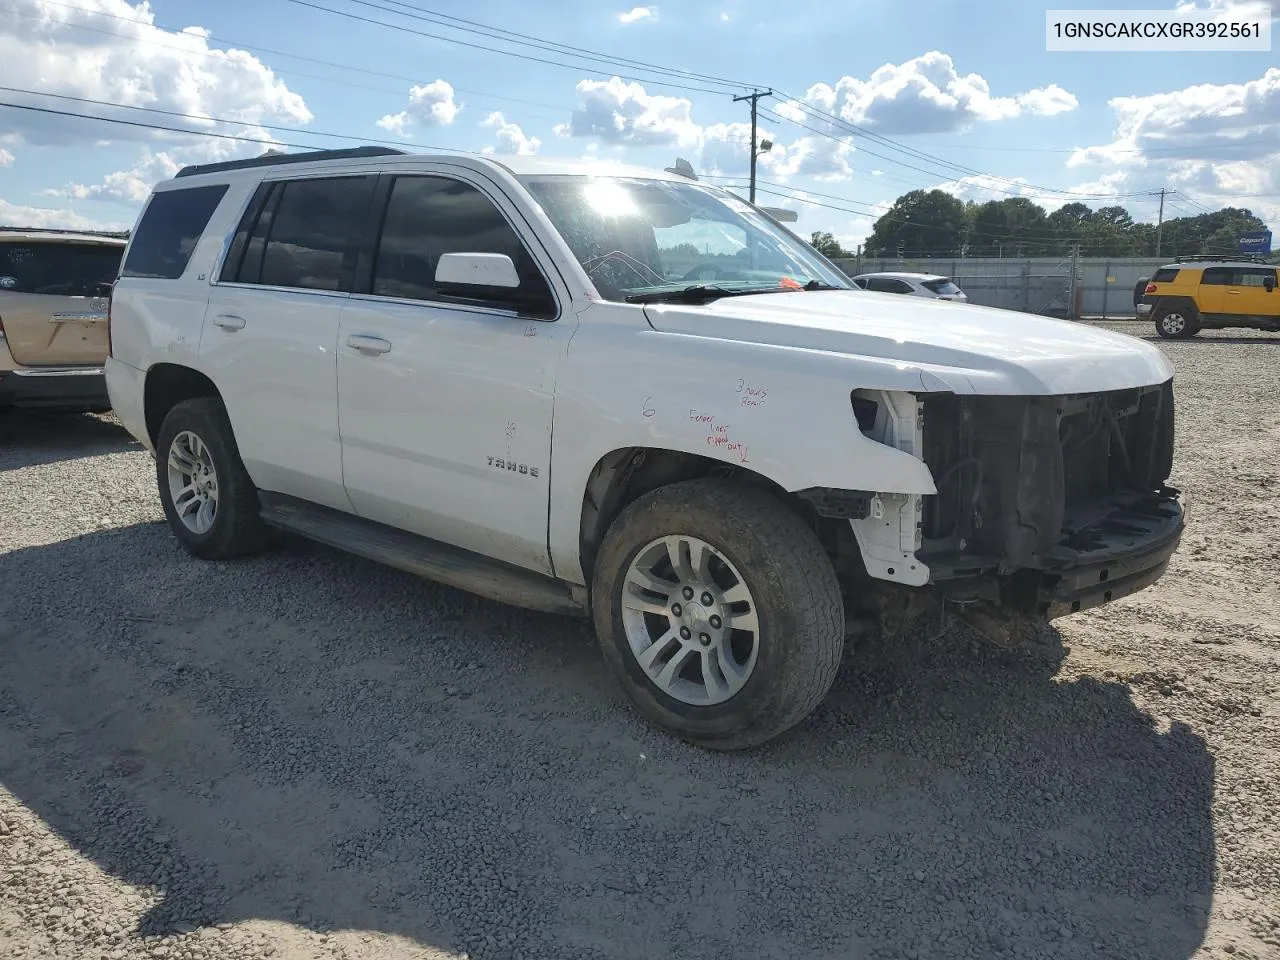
left=256, top=177, right=372, bottom=291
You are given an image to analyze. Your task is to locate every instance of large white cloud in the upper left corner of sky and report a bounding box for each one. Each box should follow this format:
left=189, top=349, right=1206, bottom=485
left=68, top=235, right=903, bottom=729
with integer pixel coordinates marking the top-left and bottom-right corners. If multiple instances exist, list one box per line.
left=0, top=0, right=311, bottom=145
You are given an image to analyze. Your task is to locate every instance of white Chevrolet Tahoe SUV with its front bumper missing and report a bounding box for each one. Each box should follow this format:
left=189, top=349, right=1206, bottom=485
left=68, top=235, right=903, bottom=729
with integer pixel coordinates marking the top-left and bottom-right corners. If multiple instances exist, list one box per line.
left=108, top=148, right=1183, bottom=749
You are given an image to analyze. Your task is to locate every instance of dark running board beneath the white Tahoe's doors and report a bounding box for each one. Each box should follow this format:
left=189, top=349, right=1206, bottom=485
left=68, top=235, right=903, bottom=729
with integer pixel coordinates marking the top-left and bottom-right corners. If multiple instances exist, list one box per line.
left=257, top=490, right=586, bottom=617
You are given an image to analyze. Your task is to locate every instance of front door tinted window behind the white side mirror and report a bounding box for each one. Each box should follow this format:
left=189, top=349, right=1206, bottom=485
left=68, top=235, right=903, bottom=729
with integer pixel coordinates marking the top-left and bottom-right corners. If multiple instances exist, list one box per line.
left=372, top=177, right=554, bottom=315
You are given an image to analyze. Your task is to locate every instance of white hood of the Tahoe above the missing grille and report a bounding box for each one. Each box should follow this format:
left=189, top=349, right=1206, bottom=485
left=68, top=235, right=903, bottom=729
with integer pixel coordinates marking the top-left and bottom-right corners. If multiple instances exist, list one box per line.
left=645, top=291, right=1172, bottom=396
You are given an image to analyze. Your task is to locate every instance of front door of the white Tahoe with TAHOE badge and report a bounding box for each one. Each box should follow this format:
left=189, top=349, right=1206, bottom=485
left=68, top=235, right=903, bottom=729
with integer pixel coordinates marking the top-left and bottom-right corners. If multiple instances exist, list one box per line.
left=338, top=168, right=576, bottom=573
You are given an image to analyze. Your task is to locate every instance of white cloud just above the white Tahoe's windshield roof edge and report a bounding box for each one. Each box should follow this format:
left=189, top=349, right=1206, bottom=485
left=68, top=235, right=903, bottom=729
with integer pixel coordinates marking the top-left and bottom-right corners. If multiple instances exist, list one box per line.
left=554, top=77, right=701, bottom=147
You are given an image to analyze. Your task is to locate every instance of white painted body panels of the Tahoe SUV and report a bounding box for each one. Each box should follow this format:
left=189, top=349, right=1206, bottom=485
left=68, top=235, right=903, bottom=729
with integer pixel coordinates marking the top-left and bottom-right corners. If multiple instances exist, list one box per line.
left=108, top=150, right=1171, bottom=585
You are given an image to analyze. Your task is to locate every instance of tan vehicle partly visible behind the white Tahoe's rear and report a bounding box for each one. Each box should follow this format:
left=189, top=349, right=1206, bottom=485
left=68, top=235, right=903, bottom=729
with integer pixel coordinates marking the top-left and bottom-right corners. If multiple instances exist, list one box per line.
left=0, top=230, right=125, bottom=411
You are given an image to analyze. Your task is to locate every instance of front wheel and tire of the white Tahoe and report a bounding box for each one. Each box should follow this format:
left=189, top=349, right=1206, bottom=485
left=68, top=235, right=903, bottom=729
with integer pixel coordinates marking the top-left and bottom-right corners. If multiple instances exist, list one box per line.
left=591, top=480, right=845, bottom=750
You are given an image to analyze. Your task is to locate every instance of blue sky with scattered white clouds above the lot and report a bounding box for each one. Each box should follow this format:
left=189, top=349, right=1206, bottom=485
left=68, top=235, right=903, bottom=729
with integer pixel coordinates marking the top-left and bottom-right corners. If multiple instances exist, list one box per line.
left=0, top=0, right=1280, bottom=248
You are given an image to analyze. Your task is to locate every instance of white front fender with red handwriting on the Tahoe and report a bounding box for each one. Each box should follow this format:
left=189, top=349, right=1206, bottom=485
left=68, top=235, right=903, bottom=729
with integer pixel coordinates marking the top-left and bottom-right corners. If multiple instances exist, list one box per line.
left=549, top=320, right=936, bottom=584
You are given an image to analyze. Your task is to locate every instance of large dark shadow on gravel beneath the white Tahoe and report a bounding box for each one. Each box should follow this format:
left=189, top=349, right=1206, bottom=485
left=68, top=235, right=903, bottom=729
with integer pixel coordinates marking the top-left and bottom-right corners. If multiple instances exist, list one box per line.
left=0, top=525, right=1215, bottom=960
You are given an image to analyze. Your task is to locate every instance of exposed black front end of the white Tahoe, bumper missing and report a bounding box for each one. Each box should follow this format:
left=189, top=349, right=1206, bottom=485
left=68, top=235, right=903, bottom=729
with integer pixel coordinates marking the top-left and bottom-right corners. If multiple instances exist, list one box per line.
left=854, top=380, right=1184, bottom=644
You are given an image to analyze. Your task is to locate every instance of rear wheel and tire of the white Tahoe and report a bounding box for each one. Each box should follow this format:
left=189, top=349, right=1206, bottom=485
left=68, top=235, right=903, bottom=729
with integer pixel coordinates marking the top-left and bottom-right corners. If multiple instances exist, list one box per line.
left=156, top=397, right=268, bottom=559
